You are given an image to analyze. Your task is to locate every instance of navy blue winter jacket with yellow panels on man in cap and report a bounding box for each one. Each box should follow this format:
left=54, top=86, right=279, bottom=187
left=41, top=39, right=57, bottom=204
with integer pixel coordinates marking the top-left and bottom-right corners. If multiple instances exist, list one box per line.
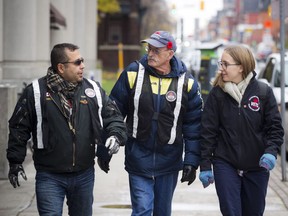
left=110, top=55, right=203, bottom=177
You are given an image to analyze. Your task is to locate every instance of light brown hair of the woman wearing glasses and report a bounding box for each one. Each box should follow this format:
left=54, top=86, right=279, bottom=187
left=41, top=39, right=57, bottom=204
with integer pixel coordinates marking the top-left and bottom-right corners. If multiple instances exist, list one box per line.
left=212, top=45, right=255, bottom=87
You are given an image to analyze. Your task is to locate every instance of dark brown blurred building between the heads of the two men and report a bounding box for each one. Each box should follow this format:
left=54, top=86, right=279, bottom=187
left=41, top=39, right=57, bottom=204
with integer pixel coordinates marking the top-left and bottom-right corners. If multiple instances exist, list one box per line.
left=97, top=0, right=143, bottom=72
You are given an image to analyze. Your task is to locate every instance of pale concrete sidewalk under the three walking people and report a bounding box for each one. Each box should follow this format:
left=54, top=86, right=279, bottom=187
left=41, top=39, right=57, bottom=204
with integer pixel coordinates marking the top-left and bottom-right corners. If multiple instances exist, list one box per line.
left=0, top=148, right=288, bottom=216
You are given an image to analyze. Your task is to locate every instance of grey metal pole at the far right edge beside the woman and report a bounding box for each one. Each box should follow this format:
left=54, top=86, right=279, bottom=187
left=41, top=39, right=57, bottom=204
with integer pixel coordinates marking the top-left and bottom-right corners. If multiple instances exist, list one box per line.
left=279, top=0, right=287, bottom=181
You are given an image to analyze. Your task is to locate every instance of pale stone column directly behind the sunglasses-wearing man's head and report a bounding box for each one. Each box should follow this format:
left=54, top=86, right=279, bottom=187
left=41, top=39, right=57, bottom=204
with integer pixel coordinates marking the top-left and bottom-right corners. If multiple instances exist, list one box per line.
left=51, top=0, right=102, bottom=82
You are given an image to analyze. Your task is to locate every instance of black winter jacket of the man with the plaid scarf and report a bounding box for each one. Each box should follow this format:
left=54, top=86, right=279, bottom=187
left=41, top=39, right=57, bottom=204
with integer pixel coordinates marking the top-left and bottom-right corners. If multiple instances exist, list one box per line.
left=7, top=77, right=127, bottom=173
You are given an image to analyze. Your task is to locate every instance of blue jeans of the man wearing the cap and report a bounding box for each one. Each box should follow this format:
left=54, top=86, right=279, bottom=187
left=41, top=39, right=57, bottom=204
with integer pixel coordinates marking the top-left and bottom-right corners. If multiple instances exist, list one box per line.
left=129, top=172, right=178, bottom=216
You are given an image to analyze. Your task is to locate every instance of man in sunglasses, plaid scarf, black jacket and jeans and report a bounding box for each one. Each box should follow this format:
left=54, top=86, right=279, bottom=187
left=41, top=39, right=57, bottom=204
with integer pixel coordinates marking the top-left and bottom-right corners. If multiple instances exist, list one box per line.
left=7, top=43, right=126, bottom=216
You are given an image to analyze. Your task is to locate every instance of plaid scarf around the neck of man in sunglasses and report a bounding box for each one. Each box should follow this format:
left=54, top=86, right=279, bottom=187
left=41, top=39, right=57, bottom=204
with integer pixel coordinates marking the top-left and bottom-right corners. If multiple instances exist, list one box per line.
left=47, top=67, right=77, bottom=119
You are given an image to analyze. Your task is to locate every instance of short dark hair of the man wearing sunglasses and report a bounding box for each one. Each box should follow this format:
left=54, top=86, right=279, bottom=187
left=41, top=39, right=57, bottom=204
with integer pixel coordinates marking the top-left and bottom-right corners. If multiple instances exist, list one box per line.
left=50, top=43, right=79, bottom=72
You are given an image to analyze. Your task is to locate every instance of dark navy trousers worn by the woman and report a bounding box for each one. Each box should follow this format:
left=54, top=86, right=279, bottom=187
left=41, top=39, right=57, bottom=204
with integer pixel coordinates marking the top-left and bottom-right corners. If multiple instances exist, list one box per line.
left=213, top=160, right=269, bottom=216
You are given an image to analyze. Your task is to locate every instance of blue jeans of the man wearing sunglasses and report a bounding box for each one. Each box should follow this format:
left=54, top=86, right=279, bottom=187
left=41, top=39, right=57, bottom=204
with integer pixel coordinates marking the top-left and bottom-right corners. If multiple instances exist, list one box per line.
left=36, top=167, right=95, bottom=216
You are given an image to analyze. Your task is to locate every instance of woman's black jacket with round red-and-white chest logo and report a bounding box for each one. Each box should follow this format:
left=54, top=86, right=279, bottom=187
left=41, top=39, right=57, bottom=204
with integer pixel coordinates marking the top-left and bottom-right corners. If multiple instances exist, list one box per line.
left=200, top=78, right=284, bottom=171
